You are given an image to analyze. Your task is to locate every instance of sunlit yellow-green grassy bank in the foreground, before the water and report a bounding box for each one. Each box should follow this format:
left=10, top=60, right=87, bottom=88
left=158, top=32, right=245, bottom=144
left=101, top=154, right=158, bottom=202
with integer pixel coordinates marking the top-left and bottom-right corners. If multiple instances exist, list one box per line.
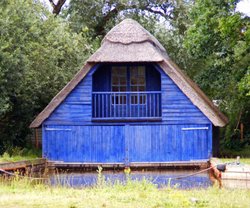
left=0, top=177, right=250, bottom=208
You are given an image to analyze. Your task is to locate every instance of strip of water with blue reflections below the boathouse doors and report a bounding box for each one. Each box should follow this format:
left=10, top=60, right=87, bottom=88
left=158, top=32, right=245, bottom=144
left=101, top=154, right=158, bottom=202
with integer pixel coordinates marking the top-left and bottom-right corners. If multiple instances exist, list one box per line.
left=50, top=170, right=212, bottom=189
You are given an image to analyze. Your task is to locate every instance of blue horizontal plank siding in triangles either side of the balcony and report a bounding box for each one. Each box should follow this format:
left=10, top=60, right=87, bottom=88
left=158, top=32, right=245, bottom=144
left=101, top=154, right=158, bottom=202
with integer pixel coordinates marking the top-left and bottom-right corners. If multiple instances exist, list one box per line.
left=45, top=64, right=211, bottom=125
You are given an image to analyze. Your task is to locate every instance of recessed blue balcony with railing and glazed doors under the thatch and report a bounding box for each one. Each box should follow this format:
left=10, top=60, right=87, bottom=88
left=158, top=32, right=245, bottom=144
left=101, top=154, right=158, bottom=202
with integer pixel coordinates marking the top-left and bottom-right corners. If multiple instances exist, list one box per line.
left=92, top=63, right=161, bottom=122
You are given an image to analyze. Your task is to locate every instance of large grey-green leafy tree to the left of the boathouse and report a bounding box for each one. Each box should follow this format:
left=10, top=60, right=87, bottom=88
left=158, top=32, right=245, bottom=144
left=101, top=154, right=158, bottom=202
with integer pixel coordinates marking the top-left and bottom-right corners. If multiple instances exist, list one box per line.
left=0, top=0, right=92, bottom=153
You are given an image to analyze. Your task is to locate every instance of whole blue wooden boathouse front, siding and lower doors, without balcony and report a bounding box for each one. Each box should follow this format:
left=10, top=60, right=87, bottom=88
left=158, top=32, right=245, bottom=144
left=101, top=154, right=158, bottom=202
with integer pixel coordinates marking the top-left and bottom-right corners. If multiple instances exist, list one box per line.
left=43, top=62, right=212, bottom=164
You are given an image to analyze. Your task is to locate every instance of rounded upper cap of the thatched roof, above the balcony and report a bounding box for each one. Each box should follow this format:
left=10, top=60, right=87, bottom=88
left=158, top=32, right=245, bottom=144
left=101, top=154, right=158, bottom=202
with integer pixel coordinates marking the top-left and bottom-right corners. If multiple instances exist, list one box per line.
left=88, top=19, right=167, bottom=63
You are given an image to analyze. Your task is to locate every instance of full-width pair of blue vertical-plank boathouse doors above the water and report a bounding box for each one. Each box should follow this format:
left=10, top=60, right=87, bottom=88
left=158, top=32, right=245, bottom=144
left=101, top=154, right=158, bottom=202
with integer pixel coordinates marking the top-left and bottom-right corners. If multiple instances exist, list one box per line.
left=43, top=124, right=212, bottom=164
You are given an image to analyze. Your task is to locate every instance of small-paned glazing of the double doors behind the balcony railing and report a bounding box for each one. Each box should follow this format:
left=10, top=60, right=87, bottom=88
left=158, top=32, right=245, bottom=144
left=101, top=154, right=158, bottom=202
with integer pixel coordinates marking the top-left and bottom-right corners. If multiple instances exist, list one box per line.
left=111, top=66, right=146, bottom=105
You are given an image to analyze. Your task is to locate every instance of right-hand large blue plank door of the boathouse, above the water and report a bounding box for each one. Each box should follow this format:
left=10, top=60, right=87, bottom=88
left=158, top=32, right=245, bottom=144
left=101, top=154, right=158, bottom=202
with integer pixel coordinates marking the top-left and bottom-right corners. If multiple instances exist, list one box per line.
left=126, top=125, right=212, bottom=163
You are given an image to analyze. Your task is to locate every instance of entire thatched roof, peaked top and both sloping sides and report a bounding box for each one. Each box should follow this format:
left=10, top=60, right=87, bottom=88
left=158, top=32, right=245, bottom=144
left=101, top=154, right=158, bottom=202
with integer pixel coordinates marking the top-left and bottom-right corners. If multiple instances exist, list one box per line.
left=30, top=19, right=228, bottom=128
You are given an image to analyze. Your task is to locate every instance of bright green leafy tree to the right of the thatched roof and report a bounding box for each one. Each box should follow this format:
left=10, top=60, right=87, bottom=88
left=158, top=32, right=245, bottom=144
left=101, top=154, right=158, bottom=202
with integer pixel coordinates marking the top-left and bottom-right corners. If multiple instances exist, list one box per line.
left=184, top=0, right=250, bottom=144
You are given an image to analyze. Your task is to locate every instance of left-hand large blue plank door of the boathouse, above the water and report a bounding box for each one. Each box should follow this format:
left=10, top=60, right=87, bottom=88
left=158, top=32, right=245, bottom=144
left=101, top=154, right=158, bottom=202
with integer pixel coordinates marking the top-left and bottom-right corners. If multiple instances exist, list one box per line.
left=43, top=125, right=125, bottom=163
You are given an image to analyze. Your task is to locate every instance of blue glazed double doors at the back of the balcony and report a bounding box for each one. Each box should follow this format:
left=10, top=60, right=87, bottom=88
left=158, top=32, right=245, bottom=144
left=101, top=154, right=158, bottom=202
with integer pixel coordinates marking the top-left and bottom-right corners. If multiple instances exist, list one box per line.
left=111, top=66, right=146, bottom=117
